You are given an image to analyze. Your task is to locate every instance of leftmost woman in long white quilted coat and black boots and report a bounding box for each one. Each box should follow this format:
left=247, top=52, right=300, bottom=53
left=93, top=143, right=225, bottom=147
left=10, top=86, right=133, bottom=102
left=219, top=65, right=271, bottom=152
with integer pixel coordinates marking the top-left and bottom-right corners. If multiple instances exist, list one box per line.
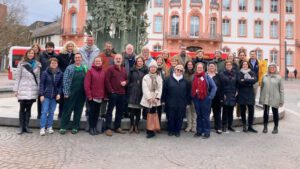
left=13, top=49, right=41, bottom=134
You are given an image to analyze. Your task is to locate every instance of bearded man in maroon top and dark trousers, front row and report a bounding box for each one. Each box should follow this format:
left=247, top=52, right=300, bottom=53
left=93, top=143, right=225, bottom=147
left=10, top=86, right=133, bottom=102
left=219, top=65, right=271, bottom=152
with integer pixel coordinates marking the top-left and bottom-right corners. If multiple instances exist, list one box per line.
left=105, top=54, right=127, bottom=136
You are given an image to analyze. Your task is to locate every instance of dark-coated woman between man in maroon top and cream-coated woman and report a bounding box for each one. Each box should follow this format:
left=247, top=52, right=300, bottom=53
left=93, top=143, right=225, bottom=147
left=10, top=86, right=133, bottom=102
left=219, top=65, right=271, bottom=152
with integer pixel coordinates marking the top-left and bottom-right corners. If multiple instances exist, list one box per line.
left=128, top=57, right=148, bottom=133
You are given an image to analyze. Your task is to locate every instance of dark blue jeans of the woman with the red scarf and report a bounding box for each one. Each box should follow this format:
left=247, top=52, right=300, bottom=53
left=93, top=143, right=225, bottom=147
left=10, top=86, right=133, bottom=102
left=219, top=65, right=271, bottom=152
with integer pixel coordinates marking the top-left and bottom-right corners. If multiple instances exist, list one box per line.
left=193, top=97, right=211, bottom=134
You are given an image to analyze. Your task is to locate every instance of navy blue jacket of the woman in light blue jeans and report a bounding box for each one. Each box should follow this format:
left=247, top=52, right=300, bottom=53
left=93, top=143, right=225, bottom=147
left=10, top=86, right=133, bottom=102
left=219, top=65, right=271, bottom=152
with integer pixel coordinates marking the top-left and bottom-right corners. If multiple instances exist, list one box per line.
left=40, top=67, right=63, bottom=99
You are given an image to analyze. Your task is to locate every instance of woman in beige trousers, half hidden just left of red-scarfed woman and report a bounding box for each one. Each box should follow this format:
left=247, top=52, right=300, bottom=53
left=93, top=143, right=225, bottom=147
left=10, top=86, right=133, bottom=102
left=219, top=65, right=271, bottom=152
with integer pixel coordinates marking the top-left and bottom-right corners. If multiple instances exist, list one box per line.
left=184, top=61, right=197, bottom=132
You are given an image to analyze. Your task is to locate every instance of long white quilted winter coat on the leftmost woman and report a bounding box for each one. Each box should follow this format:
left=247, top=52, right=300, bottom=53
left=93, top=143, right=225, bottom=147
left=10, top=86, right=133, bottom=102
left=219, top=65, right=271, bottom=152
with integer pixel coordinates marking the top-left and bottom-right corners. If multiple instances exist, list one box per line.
left=13, top=61, right=41, bottom=100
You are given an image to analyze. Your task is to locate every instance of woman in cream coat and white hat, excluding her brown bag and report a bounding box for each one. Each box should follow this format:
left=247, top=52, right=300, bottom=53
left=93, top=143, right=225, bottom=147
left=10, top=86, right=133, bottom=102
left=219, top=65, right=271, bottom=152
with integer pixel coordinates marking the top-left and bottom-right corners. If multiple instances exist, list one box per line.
left=141, top=60, right=163, bottom=138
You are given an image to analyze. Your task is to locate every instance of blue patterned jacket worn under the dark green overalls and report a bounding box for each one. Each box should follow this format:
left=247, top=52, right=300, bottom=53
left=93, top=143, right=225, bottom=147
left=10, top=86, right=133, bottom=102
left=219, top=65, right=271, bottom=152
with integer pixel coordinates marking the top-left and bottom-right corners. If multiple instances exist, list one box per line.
left=63, top=64, right=88, bottom=97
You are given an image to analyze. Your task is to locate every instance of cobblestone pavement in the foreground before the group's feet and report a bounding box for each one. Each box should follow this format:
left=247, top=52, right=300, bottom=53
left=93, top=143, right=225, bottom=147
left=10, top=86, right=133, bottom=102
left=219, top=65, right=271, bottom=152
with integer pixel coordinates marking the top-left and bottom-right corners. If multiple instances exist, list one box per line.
left=0, top=111, right=300, bottom=169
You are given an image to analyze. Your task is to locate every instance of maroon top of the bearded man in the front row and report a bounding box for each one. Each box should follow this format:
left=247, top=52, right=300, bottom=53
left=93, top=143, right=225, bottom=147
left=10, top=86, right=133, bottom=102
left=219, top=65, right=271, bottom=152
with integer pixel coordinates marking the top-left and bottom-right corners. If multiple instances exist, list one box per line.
left=105, top=65, right=127, bottom=94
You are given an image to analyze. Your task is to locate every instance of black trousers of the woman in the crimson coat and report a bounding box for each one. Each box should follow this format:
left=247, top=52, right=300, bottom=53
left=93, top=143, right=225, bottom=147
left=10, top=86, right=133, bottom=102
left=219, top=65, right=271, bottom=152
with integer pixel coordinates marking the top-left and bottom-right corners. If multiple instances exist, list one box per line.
left=89, top=100, right=101, bottom=128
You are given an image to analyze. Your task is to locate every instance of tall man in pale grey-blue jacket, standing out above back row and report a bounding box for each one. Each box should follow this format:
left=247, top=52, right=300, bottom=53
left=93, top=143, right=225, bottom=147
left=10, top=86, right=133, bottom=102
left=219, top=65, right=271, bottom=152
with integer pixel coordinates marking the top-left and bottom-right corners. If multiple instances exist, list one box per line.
left=79, top=36, right=100, bottom=69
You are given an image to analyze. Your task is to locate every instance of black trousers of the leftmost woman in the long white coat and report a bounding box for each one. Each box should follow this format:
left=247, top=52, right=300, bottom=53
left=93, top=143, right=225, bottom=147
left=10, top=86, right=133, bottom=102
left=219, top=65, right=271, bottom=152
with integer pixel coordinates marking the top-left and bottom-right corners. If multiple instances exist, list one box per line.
left=19, top=100, right=34, bottom=130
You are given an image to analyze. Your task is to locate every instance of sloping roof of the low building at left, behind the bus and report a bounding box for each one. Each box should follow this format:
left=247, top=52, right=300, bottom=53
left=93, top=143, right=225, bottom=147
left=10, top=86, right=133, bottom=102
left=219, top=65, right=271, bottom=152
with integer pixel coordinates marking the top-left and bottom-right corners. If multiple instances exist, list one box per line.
left=31, top=22, right=60, bottom=38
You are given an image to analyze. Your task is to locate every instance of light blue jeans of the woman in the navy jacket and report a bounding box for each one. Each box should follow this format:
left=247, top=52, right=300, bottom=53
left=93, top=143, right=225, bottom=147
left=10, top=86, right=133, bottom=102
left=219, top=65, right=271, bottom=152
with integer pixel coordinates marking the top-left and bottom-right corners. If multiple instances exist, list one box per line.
left=40, top=98, right=56, bottom=128
